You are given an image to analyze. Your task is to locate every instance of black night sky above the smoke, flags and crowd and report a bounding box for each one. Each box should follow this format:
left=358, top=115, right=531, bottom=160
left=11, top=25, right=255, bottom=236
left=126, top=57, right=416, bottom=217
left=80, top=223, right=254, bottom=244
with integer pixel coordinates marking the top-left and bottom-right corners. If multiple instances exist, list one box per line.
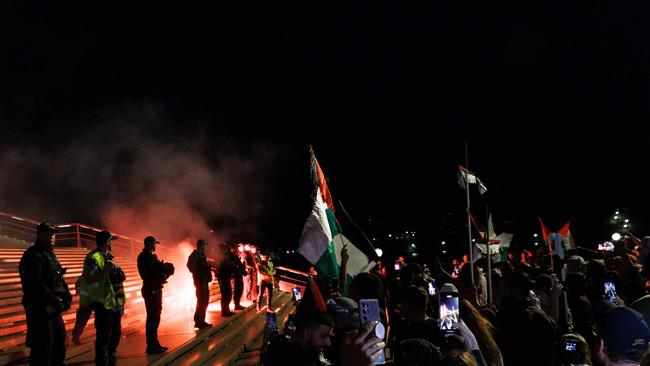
left=0, top=1, right=650, bottom=254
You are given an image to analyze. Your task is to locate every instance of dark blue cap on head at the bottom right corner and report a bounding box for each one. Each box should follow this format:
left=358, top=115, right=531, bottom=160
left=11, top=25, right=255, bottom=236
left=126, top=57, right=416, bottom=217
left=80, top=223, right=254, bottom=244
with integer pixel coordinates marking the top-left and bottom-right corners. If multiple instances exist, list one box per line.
left=598, top=307, right=650, bottom=356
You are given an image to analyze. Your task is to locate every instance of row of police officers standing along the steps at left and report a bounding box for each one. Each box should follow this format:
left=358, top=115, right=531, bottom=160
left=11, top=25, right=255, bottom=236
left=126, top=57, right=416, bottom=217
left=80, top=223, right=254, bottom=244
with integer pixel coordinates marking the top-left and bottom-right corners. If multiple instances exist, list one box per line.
left=19, top=222, right=275, bottom=366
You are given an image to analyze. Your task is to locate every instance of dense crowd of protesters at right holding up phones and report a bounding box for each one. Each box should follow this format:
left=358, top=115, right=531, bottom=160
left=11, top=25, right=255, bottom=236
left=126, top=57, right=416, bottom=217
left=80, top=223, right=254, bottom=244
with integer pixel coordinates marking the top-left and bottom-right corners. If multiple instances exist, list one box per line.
left=262, top=235, right=650, bottom=366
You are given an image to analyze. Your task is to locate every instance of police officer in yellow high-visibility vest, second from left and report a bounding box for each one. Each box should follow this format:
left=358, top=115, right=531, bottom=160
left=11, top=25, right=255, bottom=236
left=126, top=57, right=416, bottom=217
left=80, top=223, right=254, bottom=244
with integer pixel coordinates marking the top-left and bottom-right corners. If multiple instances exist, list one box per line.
left=79, top=230, right=117, bottom=365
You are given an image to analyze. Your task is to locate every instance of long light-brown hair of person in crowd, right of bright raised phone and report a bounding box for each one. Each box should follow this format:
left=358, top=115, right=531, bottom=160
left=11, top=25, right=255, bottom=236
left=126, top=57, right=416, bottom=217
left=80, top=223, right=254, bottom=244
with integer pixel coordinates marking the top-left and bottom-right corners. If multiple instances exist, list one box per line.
left=460, top=299, right=503, bottom=366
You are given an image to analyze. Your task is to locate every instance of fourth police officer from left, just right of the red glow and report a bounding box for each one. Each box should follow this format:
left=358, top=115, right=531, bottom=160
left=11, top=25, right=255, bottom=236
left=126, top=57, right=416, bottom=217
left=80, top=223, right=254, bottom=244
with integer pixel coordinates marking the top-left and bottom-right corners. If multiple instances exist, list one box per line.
left=187, top=239, right=212, bottom=329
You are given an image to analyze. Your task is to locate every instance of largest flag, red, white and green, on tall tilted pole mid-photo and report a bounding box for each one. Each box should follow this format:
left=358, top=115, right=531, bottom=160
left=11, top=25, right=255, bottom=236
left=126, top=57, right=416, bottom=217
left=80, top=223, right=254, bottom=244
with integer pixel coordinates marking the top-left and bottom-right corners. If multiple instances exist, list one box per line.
left=298, top=146, right=375, bottom=283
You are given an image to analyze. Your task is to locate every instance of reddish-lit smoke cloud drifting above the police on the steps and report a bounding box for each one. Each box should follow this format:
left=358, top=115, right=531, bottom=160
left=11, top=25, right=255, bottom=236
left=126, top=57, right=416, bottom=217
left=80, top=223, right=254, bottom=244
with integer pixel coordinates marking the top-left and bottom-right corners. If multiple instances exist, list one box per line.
left=0, top=104, right=278, bottom=250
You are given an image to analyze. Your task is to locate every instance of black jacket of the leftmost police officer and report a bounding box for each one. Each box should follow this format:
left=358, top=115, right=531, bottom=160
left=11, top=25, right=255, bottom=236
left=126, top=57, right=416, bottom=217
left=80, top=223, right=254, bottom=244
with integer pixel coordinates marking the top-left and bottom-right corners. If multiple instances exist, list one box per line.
left=18, top=244, right=72, bottom=312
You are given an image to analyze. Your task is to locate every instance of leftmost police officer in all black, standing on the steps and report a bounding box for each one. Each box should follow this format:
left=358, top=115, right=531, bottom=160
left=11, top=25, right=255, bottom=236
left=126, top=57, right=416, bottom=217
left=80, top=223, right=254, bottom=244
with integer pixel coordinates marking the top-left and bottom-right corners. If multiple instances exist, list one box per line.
left=18, top=222, right=72, bottom=365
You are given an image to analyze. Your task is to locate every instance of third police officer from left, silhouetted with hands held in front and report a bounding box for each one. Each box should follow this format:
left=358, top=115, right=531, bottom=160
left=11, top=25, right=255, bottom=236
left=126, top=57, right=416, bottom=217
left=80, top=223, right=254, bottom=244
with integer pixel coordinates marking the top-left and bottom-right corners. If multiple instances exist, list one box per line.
left=138, top=236, right=174, bottom=355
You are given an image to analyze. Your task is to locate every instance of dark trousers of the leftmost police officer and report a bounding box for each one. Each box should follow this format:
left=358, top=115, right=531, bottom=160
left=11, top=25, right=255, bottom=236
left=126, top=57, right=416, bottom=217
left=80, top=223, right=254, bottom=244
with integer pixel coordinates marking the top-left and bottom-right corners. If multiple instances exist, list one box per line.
left=25, top=309, right=65, bottom=366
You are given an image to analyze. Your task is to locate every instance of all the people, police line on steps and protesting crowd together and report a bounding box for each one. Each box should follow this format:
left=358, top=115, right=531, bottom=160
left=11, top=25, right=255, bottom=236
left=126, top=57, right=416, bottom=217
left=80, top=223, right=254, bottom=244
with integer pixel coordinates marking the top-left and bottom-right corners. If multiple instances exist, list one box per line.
left=19, top=223, right=650, bottom=366
